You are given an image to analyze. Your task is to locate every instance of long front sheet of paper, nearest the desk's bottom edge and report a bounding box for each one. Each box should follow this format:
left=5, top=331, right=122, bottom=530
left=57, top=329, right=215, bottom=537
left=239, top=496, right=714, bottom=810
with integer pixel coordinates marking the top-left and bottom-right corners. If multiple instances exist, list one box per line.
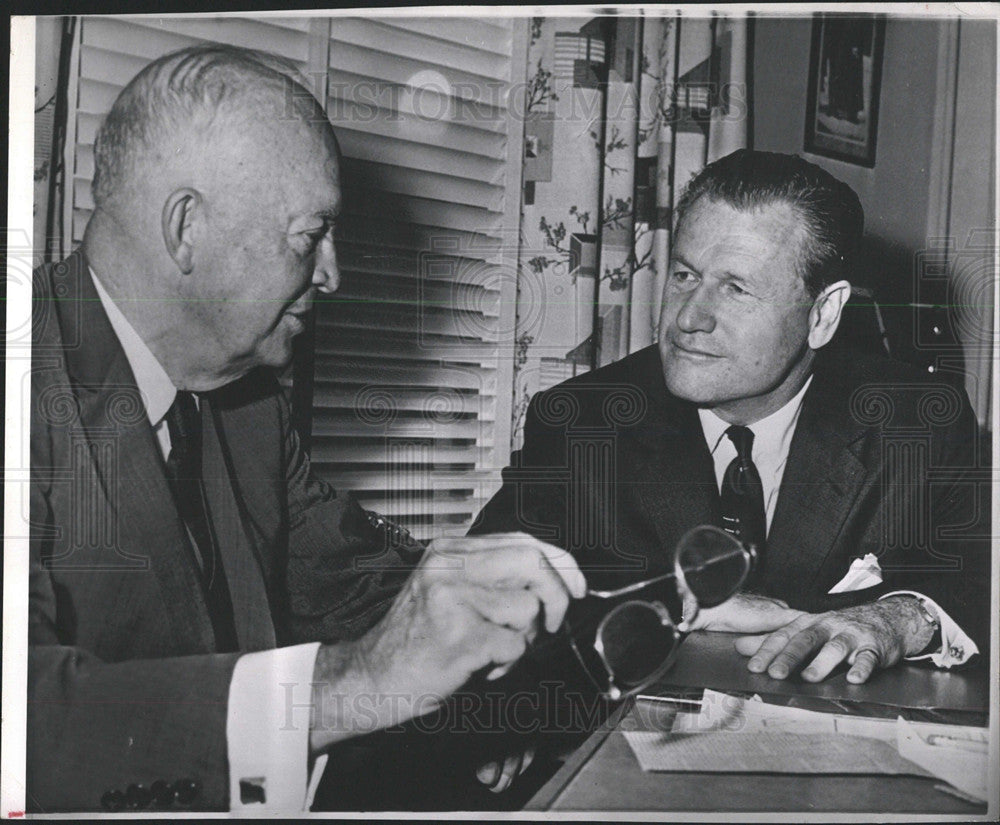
left=623, top=731, right=931, bottom=776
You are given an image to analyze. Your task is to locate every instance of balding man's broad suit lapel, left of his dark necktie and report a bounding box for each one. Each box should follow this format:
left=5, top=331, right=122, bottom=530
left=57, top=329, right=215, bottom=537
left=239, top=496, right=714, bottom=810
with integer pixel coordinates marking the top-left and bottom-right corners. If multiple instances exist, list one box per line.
left=58, top=252, right=214, bottom=650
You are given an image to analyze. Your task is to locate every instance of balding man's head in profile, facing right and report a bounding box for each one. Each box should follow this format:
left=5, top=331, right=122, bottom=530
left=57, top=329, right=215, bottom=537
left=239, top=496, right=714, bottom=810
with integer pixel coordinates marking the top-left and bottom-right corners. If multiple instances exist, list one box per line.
left=84, top=46, right=341, bottom=390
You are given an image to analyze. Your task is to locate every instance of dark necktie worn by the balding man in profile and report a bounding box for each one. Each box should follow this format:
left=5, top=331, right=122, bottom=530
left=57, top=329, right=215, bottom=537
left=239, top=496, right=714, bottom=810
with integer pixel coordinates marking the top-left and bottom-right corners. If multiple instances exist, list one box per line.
left=167, top=392, right=237, bottom=652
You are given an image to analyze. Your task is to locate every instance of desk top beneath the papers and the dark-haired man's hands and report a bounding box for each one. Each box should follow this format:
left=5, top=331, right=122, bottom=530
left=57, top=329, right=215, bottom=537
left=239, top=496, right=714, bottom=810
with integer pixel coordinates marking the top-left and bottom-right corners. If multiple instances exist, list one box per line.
left=526, top=633, right=989, bottom=815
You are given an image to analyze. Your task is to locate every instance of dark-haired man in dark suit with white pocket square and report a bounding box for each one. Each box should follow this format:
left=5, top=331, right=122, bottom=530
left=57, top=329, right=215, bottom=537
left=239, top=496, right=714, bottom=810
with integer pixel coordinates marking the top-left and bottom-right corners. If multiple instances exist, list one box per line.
left=473, top=150, right=990, bottom=682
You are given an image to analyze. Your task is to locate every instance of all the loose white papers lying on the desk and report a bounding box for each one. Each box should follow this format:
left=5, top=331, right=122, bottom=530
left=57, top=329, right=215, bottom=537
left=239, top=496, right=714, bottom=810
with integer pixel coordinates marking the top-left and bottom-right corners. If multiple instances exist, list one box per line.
left=624, top=690, right=989, bottom=802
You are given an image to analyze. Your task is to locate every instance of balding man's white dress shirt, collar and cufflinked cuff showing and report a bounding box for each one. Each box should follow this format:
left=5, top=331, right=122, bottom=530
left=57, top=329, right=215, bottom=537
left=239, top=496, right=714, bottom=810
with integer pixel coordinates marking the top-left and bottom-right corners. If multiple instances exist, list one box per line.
left=90, top=269, right=327, bottom=813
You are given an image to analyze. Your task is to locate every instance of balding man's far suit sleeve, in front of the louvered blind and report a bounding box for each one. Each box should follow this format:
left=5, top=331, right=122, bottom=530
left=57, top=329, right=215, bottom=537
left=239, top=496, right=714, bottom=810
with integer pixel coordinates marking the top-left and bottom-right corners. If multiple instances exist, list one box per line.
left=279, top=398, right=424, bottom=642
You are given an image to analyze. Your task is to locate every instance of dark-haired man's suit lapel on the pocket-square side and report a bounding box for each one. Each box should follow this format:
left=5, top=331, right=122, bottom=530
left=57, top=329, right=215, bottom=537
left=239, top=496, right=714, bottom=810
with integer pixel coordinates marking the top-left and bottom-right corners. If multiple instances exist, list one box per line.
left=762, top=356, right=867, bottom=593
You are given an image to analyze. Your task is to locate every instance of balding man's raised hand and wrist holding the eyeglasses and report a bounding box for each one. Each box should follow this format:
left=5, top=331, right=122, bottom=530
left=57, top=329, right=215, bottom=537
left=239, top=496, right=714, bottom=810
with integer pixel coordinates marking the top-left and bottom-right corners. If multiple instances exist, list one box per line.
left=310, top=533, right=587, bottom=750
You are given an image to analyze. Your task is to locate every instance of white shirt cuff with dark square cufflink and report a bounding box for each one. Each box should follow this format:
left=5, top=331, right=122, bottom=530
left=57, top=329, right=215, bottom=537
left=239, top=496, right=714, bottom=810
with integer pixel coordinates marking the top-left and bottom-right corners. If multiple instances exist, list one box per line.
left=226, top=642, right=327, bottom=814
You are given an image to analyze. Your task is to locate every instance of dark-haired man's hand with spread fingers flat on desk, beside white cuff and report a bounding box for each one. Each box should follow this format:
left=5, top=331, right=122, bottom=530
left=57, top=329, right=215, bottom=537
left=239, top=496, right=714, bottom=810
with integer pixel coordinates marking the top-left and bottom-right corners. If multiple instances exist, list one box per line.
left=736, top=596, right=934, bottom=684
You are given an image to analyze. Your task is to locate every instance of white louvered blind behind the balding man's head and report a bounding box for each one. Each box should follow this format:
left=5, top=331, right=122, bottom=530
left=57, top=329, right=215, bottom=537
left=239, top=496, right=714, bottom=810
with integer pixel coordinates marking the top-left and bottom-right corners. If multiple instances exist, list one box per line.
left=67, top=15, right=525, bottom=538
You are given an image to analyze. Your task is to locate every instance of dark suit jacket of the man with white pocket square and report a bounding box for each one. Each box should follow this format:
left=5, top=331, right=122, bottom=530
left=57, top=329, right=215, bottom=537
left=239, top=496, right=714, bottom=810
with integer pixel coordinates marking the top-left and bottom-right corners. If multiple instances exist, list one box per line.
left=472, top=347, right=990, bottom=654
